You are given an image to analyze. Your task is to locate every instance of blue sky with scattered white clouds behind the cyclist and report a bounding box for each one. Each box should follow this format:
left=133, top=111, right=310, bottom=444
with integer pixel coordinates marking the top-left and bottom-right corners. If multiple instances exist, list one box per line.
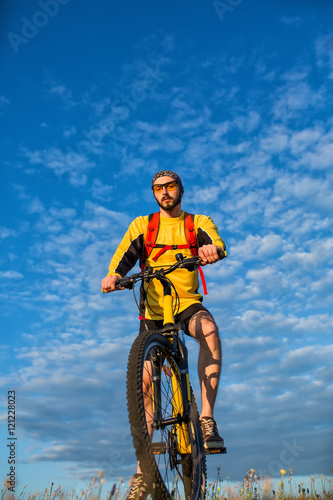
left=0, top=0, right=333, bottom=491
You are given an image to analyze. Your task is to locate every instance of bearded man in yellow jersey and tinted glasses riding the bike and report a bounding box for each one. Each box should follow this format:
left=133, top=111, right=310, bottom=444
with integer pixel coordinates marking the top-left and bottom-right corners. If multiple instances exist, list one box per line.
left=102, top=170, right=226, bottom=498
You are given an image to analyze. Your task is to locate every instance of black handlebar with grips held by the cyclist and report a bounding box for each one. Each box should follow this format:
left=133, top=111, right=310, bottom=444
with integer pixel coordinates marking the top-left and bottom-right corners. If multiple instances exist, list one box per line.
left=116, top=249, right=225, bottom=290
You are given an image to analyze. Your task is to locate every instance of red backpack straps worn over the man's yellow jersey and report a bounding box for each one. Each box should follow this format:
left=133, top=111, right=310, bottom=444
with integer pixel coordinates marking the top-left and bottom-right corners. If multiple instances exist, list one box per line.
left=141, top=212, right=207, bottom=295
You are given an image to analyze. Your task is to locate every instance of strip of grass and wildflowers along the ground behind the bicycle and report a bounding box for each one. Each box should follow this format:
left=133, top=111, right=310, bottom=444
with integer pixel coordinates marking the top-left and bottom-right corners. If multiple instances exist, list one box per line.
left=1, top=468, right=333, bottom=500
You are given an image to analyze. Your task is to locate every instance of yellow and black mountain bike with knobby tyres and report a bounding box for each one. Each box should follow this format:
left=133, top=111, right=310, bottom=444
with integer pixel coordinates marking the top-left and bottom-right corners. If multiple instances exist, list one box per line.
left=116, top=254, right=226, bottom=500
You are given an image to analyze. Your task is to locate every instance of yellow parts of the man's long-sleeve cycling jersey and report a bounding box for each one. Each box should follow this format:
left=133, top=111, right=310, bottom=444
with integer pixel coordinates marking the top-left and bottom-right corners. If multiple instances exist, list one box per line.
left=108, top=212, right=225, bottom=320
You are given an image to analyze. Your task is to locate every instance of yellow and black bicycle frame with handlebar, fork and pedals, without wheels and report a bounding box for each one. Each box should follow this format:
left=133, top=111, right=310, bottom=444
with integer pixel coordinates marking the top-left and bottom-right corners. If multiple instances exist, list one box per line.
left=116, top=250, right=226, bottom=466
